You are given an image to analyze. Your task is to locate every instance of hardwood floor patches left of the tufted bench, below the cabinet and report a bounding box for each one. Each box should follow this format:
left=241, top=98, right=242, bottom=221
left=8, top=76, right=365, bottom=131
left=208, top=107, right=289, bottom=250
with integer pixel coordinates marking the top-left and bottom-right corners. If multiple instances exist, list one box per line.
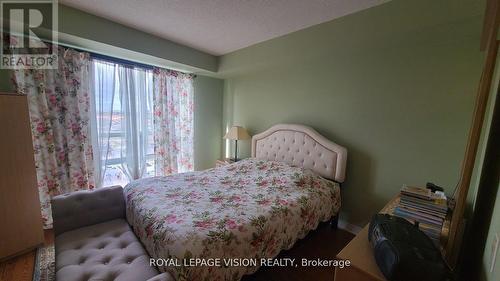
left=0, top=230, right=54, bottom=281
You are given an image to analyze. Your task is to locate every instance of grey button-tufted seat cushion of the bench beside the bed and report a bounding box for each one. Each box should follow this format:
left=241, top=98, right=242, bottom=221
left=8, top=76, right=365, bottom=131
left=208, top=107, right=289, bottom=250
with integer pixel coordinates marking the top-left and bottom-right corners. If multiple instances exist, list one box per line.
left=55, top=219, right=162, bottom=281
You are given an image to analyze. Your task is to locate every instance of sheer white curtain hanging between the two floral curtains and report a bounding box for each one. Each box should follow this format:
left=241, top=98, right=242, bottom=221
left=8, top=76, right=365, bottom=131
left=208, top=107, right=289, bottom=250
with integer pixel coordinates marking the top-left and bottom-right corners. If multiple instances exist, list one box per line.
left=91, top=59, right=154, bottom=186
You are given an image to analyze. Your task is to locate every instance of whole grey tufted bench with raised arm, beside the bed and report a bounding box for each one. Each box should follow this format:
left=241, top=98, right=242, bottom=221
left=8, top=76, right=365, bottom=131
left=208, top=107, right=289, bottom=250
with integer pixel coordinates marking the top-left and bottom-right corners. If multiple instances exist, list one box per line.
left=52, top=186, right=174, bottom=281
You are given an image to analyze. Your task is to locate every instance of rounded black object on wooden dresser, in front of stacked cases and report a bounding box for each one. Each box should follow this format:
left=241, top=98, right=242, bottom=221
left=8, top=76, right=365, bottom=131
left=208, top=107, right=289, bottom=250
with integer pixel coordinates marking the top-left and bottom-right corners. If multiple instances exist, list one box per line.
left=368, top=214, right=451, bottom=281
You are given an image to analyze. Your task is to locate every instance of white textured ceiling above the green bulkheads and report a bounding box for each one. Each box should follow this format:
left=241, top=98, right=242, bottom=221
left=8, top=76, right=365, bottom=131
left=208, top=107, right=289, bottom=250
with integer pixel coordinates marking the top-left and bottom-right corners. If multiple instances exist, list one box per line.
left=59, top=0, right=389, bottom=55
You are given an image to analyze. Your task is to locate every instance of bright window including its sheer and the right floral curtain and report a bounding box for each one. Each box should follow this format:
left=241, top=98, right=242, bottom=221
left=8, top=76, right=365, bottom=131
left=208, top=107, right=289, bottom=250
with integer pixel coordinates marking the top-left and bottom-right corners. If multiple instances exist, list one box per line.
left=90, top=58, right=194, bottom=187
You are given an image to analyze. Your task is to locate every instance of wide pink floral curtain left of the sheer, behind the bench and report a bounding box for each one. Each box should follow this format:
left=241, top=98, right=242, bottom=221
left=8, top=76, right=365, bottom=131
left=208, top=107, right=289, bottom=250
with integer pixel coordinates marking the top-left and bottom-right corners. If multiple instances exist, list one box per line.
left=14, top=47, right=95, bottom=228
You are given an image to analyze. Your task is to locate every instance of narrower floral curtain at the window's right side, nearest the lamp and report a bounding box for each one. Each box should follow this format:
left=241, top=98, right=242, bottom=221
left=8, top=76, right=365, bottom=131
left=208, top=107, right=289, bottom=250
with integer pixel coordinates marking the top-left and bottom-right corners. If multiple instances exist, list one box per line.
left=153, top=68, right=194, bottom=176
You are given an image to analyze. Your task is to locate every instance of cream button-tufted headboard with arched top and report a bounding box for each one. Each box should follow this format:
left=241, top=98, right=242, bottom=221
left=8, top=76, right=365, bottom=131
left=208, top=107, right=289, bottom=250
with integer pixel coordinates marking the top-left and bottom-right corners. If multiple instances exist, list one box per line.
left=252, top=124, right=347, bottom=182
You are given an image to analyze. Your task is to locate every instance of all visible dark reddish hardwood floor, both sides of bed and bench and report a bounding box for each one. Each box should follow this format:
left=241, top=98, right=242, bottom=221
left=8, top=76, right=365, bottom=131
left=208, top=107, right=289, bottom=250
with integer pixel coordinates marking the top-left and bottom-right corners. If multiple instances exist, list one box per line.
left=0, top=223, right=354, bottom=281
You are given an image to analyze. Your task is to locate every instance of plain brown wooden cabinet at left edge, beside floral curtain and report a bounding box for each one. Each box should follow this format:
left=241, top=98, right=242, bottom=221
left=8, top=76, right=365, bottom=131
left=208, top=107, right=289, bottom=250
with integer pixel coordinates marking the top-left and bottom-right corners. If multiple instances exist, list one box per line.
left=0, top=93, right=43, bottom=260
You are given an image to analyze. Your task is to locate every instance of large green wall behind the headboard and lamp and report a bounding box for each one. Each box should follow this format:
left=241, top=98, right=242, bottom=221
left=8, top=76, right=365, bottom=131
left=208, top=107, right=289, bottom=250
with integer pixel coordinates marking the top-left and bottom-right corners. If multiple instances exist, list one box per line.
left=219, top=0, right=485, bottom=225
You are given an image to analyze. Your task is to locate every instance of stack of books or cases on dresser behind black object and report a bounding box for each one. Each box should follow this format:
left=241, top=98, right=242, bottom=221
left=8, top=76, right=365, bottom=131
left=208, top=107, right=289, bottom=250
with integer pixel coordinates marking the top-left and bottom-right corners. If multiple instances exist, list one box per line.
left=394, top=185, right=448, bottom=245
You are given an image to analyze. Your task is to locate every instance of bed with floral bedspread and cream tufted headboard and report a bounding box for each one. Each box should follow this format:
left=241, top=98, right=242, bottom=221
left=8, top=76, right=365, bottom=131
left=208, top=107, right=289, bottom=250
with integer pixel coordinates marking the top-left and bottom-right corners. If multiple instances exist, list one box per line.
left=124, top=124, right=347, bottom=281
